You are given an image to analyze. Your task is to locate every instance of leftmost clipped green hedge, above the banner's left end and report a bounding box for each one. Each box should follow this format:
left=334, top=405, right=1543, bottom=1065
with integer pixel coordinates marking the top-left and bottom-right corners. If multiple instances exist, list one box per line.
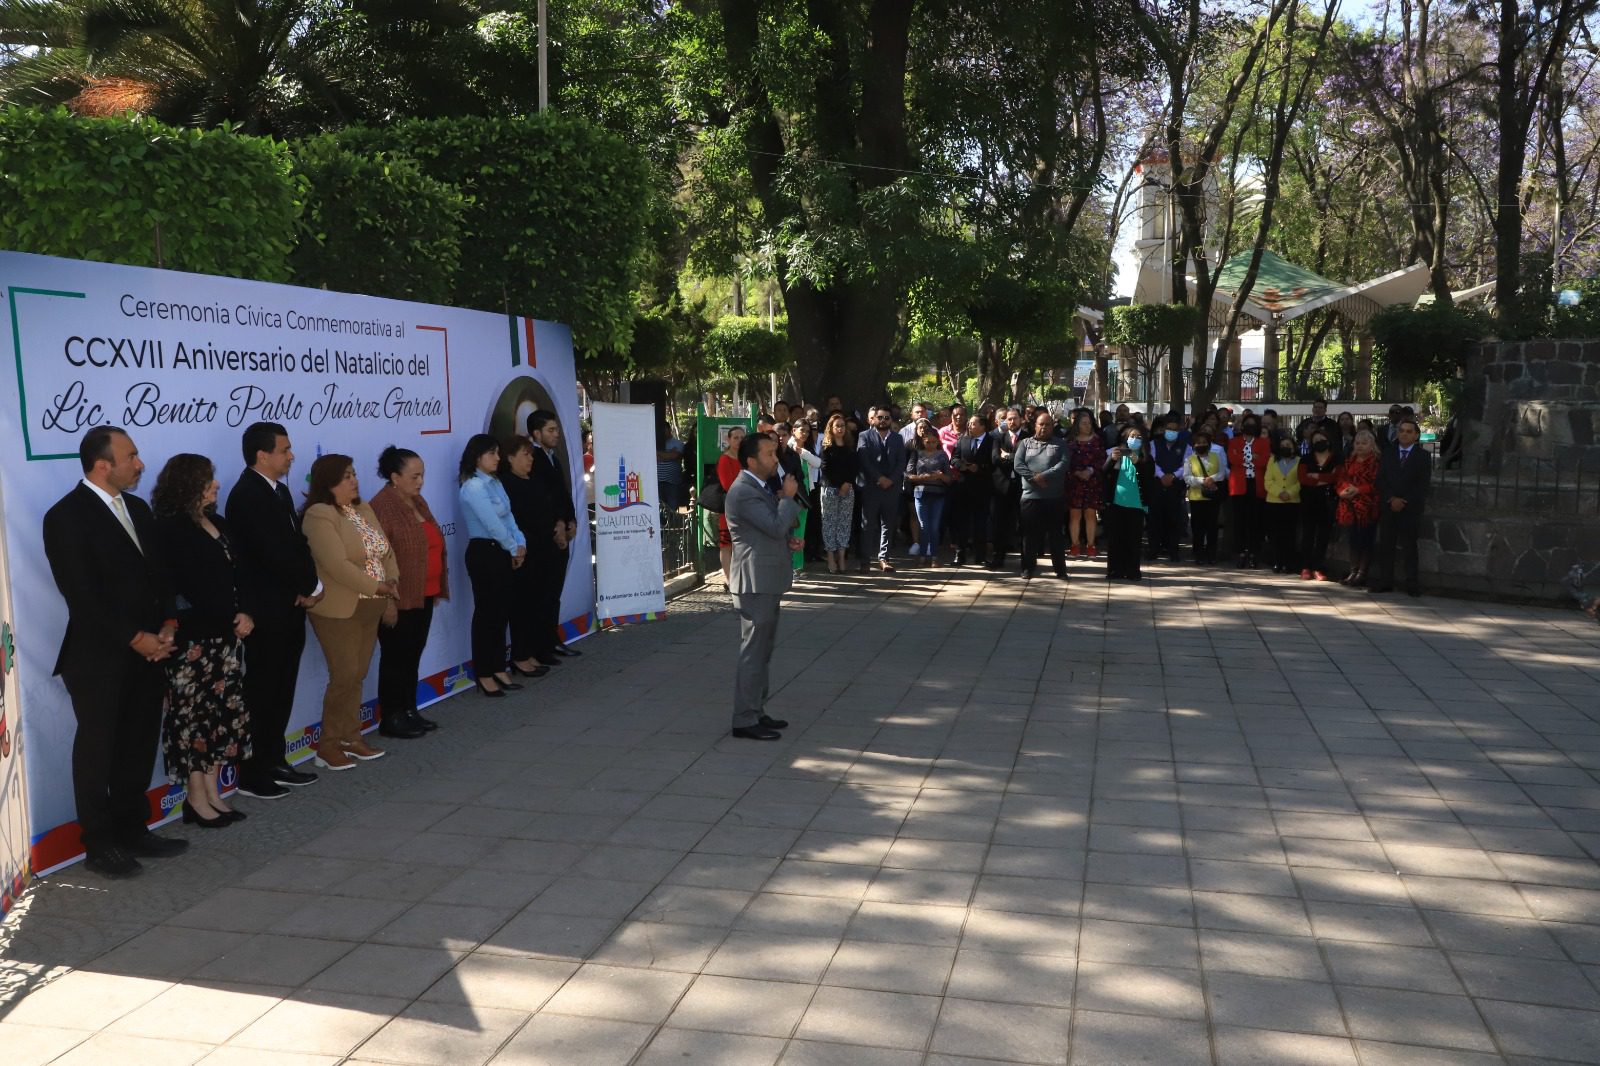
left=0, top=107, right=302, bottom=282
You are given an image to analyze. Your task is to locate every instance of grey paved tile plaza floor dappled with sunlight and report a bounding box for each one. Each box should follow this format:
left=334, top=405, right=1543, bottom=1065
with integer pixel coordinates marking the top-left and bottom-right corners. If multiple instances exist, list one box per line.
left=0, top=565, right=1600, bottom=1066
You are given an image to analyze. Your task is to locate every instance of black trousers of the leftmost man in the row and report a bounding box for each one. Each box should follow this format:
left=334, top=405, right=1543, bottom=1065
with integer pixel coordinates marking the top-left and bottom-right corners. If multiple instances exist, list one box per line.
left=61, top=651, right=164, bottom=855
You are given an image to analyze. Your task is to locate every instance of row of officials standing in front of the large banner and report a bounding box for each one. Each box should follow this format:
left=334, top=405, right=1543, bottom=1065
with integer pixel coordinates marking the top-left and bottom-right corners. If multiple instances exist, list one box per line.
left=43, top=411, right=578, bottom=877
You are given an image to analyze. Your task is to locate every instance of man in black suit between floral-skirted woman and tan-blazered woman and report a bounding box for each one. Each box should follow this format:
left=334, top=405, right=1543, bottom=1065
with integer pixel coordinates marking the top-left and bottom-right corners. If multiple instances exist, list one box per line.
left=226, top=423, right=322, bottom=799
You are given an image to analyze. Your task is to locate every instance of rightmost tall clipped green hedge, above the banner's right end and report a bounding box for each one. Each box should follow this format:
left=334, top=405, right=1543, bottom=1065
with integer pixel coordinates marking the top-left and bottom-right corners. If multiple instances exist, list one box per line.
left=336, top=114, right=654, bottom=349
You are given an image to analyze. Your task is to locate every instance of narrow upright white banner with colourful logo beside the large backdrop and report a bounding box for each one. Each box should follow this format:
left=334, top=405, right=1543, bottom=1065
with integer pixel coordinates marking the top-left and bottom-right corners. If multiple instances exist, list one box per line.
left=594, top=403, right=667, bottom=623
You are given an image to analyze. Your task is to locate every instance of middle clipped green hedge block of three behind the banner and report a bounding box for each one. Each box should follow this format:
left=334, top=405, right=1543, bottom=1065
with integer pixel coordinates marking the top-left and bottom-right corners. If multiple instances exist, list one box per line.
left=290, top=136, right=466, bottom=304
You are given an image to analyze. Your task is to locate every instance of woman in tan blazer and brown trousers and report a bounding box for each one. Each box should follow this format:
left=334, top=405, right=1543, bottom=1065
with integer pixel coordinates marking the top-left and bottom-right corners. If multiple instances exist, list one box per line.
left=301, top=455, right=400, bottom=770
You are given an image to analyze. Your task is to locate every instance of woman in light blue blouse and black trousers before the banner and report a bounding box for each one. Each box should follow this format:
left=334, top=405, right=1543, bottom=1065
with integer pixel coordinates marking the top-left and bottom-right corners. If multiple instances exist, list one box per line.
left=458, top=434, right=528, bottom=698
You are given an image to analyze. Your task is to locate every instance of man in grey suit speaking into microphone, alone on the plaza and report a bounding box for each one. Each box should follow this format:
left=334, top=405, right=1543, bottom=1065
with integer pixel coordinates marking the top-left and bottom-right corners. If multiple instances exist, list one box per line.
left=723, top=434, right=802, bottom=739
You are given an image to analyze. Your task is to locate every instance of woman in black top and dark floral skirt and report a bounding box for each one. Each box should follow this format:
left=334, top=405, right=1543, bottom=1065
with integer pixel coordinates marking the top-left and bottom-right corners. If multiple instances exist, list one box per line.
left=150, top=455, right=254, bottom=829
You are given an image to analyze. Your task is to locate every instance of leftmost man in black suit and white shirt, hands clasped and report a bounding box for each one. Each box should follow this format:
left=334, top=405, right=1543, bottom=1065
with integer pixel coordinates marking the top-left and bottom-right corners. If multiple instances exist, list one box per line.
left=45, top=426, right=189, bottom=877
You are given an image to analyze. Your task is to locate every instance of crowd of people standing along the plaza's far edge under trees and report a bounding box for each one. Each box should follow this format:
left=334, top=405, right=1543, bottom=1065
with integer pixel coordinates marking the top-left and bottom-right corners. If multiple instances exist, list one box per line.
left=707, top=397, right=1432, bottom=595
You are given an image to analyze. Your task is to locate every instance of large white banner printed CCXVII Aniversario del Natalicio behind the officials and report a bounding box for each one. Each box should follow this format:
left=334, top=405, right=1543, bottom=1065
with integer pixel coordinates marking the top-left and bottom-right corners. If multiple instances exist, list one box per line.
left=0, top=253, right=594, bottom=871
